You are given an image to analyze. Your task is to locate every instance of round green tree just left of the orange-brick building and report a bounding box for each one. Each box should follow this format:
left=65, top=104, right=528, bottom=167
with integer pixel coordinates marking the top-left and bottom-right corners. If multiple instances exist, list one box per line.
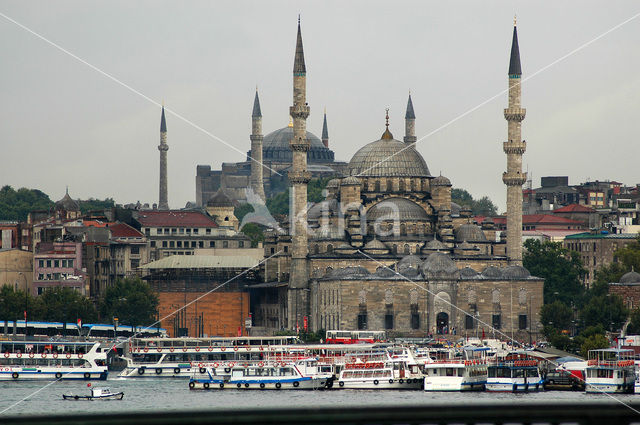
left=100, top=278, right=158, bottom=326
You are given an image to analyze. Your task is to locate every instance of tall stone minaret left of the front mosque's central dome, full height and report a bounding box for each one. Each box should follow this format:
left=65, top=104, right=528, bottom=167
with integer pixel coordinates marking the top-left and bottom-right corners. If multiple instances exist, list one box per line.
left=288, top=18, right=311, bottom=329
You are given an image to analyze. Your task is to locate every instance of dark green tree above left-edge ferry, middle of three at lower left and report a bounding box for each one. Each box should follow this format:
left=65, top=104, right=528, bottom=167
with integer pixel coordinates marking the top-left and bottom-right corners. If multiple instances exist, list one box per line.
left=36, top=287, right=98, bottom=323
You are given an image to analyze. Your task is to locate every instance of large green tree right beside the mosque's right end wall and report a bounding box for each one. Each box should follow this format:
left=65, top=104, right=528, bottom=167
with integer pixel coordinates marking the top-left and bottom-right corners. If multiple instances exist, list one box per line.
left=522, top=239, right=585, bottom=306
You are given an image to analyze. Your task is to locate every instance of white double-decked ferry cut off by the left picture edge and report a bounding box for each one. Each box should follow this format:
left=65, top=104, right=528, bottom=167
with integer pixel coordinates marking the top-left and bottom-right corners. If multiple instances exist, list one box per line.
left=0, top=341, right=109, bottom=381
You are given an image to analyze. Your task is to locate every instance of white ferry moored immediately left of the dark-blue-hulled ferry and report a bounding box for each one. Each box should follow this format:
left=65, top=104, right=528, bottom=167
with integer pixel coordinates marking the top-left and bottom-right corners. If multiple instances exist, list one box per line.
left=424, top=348, right=488, bottom=391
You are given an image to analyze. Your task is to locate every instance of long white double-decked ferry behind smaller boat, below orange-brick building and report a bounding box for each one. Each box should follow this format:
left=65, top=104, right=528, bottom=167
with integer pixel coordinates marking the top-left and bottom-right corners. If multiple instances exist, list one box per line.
left=118, top=336, right=298, bottom=379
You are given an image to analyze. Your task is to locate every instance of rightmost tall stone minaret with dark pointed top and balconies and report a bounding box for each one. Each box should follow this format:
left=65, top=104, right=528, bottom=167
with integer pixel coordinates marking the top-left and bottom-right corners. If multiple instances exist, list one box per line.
left=502, top=18, right=527, bottom=265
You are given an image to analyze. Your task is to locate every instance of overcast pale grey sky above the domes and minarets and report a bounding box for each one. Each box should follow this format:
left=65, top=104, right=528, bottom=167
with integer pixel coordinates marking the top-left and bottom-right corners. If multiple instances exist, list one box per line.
left=0, top=0, right=640, bottom=210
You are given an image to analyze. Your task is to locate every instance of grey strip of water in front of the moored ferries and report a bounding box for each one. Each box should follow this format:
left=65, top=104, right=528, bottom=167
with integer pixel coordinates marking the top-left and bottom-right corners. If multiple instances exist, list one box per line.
left=0, top=378, right=640, bottom=416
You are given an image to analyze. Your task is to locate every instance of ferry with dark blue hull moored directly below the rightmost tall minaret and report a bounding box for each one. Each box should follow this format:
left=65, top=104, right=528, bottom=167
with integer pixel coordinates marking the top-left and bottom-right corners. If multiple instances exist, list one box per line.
left=485, top=352, right=544, bottom=393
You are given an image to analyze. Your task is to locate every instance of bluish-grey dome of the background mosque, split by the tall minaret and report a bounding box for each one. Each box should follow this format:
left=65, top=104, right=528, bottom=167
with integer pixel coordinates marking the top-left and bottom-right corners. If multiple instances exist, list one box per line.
left=248, top=127, right=334, bottom=163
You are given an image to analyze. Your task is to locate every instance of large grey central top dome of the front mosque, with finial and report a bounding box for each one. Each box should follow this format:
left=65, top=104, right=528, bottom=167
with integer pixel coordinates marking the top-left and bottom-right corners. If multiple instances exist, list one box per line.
left=349, top=133, right=431, bottom=177
